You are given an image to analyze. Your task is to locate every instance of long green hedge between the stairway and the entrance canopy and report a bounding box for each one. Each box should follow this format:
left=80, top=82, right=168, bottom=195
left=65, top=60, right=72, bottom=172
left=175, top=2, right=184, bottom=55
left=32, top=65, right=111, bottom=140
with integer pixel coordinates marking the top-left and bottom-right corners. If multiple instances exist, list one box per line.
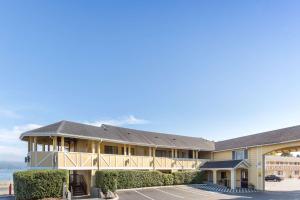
left=96, top=170, right=202, bottom=193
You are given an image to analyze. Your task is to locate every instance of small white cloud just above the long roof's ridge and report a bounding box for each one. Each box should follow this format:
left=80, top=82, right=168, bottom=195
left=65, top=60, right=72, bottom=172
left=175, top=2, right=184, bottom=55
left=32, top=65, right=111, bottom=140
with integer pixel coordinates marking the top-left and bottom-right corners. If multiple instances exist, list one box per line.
left=84, top=115, right=149, bottom=126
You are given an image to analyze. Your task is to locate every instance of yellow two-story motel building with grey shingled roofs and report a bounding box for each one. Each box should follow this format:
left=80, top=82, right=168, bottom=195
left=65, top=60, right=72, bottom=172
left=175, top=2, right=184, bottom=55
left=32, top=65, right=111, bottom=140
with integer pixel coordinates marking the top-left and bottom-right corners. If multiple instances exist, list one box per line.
left=20, top=121, right=300, bottom=193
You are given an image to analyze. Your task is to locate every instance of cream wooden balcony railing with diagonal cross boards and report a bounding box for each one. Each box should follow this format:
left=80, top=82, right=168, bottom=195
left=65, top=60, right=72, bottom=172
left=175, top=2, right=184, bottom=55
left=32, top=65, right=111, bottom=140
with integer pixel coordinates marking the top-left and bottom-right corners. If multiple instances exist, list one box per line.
left=28, top=151, right=208, bottom=170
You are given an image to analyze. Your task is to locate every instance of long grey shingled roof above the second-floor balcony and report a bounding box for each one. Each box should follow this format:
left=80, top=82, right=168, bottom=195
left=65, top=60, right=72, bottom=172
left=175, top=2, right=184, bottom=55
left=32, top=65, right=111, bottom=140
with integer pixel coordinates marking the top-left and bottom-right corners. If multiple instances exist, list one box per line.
left=20, top=121, right=214, bottom=151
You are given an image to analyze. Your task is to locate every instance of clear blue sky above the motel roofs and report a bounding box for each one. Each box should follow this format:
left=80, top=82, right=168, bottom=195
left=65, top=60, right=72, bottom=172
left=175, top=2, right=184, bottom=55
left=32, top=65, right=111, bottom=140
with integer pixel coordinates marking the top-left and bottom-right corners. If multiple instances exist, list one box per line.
left=0, top=0, right=300, bottom=161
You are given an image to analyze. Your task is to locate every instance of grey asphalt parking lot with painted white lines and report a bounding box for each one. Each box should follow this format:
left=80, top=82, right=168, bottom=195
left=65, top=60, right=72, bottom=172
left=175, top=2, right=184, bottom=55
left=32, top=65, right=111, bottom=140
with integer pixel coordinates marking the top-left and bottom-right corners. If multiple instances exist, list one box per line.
left=118, top=186, right=300, bottom=200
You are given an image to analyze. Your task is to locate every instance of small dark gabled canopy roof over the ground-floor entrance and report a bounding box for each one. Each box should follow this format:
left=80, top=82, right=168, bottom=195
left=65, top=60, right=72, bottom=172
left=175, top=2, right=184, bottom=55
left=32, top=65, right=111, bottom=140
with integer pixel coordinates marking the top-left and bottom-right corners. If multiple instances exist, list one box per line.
left=200, top=160, right=249, bottom=170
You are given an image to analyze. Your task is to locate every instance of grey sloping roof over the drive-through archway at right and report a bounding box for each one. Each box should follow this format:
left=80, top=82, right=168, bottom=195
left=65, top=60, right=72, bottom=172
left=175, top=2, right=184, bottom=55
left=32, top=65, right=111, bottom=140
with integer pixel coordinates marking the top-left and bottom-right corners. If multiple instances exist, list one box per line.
left=215, top=126, right=300, bottom=151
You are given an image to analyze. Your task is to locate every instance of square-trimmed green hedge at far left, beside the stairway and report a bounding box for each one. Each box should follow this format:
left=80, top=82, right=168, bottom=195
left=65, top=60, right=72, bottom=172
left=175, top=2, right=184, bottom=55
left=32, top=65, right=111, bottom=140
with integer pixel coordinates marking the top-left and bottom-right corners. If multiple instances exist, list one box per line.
left=13, top=170, right=69, bottom=200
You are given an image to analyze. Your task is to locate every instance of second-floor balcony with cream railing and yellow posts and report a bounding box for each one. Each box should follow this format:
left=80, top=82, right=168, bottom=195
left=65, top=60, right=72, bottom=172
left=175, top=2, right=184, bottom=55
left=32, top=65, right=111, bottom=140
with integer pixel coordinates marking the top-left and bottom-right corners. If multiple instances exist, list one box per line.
left=26, top=135, right=210, bottom=170
